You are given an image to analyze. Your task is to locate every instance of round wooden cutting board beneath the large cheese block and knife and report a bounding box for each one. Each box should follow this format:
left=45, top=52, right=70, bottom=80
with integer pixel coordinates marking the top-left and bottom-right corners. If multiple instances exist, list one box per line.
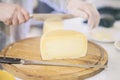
left=1, top=37, right=108, bottom=80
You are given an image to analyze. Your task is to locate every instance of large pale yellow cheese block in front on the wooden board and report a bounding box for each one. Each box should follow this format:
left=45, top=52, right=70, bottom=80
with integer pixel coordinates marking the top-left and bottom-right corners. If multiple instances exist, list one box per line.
left=40, top=30, right=87, bottom=60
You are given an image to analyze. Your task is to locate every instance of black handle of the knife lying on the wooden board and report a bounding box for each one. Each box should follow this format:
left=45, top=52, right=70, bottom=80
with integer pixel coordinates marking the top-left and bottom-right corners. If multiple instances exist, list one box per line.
left=0, top=57, right=21, bottom=64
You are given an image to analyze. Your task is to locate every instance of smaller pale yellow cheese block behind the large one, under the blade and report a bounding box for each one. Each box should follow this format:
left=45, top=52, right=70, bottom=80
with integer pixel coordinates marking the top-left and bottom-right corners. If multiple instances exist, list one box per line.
left=43, top=18, right=63, bottom=34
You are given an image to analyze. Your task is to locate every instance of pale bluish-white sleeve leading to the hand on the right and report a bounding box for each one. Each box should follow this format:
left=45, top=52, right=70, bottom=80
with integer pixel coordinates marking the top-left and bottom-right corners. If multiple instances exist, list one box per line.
left=40, top=0, right=67, bottom=13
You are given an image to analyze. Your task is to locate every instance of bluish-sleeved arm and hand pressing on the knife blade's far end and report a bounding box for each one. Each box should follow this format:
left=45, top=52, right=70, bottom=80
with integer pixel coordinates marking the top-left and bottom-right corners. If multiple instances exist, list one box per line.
left=42, top=0, right=100, bottom=28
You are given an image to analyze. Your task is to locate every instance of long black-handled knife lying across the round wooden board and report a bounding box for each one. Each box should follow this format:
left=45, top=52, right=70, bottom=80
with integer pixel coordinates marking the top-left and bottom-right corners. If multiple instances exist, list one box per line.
left=0, top=57, right=107, bottom=68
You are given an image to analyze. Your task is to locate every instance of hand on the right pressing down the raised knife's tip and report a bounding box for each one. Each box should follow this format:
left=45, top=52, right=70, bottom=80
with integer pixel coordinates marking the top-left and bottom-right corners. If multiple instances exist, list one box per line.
left=67, top=0, right=100, bottom=28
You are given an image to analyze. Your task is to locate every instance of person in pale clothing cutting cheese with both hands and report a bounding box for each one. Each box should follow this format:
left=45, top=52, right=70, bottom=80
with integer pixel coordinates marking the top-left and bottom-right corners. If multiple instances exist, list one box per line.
left=0, top=0, right=99, bottom=41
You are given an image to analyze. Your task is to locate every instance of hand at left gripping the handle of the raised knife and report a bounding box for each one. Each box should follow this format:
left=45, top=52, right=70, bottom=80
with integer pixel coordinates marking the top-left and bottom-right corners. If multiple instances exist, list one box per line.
left=0, top=3, right=29, bottom=25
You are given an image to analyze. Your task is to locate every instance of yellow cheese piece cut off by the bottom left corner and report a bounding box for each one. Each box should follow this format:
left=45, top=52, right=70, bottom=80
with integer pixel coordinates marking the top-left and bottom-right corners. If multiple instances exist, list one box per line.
left=0, top=70, right=15, bottom=80
